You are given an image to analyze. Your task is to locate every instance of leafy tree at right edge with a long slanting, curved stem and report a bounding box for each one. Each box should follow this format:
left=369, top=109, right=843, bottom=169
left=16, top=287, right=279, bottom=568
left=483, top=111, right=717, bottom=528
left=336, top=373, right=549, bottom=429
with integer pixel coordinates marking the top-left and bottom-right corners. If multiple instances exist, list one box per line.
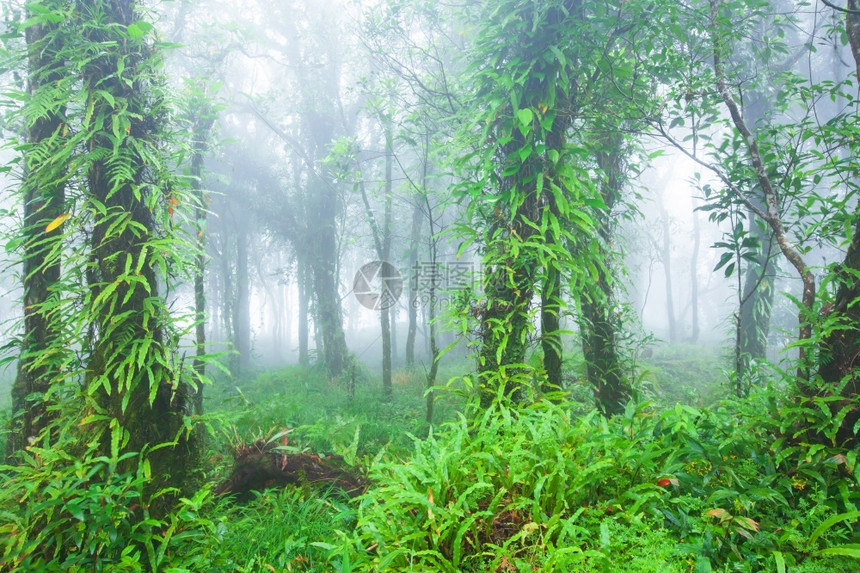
left=655, top=0, right=860, bottom=436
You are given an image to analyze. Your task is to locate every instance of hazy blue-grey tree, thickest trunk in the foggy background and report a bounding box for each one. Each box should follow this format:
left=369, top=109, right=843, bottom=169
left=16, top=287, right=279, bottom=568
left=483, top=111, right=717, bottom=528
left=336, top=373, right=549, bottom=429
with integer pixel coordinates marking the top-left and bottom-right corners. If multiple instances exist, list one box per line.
left=245, top=2, right=349, bottom=376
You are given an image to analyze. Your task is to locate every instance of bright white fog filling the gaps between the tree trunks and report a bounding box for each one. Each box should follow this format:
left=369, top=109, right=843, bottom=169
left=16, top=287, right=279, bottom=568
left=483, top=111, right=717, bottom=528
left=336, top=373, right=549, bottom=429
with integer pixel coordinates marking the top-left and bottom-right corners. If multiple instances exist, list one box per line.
left=0, top=0, right=851, bottom=399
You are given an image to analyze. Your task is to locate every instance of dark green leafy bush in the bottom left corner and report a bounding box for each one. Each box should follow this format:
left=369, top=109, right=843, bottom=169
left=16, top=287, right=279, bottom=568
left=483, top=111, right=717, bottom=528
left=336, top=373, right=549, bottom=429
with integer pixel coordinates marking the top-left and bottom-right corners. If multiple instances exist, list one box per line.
left=0, top=428, right=225, bottom=572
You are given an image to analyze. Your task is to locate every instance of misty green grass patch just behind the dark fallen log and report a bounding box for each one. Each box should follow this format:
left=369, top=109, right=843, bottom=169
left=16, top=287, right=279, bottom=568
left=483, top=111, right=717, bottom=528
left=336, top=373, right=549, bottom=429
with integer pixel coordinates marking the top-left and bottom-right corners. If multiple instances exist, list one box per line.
left=206, top=365, right=462, bottom=462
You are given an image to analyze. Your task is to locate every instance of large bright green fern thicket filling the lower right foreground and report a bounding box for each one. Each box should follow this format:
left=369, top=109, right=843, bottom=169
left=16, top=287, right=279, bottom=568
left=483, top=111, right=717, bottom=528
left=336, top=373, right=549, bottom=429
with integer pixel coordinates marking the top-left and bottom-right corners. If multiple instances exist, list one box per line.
left=332, top=388, right=857, bottom=572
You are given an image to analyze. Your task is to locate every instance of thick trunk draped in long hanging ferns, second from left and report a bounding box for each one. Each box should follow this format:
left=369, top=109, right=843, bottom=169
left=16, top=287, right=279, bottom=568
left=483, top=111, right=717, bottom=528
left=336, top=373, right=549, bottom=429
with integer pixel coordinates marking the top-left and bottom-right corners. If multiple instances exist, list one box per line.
left=79, top=0, right=197, bottom=510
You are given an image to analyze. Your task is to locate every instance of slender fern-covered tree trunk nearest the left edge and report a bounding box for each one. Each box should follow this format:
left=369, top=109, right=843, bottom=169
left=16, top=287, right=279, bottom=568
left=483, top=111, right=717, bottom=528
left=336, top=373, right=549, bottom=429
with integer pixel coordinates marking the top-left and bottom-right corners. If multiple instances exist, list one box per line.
left=6, top=10, right=65, bottom=460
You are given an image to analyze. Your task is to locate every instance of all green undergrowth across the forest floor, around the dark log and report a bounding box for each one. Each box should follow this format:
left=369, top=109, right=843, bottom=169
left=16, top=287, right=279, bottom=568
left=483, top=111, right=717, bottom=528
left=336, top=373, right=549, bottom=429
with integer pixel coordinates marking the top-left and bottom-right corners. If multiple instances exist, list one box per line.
left=0, top=368, right=860, bottom=573
